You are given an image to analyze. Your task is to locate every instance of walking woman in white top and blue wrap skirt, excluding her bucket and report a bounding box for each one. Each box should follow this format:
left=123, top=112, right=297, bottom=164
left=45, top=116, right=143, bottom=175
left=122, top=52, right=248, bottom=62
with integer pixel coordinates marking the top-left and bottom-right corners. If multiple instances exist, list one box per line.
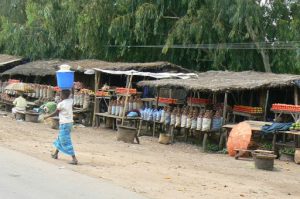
left=45, top=90, right=78, bottom=165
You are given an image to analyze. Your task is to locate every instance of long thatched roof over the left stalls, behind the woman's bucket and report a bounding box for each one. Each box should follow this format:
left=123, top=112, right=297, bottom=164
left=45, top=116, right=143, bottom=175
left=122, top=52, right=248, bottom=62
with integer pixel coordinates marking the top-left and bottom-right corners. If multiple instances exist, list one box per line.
left=2, top=59, right=188, bottom=76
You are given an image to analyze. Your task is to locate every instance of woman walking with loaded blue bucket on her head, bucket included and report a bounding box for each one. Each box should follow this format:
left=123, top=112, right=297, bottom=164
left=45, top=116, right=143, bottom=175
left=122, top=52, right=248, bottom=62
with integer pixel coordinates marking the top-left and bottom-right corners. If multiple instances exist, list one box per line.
left=45, top=65, right=78, bottom=165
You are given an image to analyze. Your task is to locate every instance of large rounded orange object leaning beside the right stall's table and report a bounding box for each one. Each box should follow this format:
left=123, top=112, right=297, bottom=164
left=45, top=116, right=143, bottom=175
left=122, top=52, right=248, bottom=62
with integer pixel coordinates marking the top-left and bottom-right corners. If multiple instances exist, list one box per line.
left=227, top=122, right=252, bottom=156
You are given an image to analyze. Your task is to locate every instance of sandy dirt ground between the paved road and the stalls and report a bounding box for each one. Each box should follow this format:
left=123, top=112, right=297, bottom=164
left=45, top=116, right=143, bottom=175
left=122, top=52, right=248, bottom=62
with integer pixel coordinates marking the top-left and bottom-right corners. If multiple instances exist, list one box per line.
left=0, top=117, right=300, bottom=199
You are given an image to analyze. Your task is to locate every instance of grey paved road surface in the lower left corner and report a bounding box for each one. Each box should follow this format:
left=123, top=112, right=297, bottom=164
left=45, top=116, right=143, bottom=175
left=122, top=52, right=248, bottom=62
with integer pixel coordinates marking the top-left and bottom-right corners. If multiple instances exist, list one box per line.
left=0, top=147, right=144, bottom=199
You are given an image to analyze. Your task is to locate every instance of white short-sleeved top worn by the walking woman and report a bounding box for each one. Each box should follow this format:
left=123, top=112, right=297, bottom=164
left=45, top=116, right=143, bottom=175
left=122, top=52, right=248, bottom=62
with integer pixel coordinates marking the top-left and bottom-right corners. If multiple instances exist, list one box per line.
left=57, top=99, right=73, bottom=124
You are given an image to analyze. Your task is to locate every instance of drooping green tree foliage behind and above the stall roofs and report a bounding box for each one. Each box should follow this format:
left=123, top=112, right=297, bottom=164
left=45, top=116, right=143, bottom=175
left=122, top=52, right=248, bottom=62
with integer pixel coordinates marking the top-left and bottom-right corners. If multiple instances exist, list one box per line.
left=0, top=0, right=300, bottom=73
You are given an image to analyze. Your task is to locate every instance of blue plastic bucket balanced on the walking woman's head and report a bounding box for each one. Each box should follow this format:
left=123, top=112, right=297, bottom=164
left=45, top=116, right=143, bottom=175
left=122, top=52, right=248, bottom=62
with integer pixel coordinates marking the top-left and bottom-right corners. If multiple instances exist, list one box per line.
left=56, top=71, right=74, bottom=90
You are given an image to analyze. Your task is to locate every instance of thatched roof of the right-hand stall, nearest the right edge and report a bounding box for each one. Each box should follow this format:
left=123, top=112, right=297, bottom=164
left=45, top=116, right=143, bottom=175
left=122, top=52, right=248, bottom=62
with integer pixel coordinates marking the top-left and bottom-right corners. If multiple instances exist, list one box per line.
left=138, top=71, right=300, bottom=92
